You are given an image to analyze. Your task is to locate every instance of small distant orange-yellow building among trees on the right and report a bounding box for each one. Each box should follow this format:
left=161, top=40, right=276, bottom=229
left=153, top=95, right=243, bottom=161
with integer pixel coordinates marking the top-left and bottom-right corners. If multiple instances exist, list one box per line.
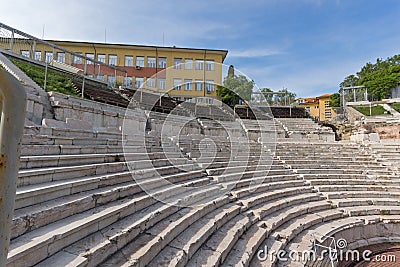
left=296, top=94, right=336, bottom=121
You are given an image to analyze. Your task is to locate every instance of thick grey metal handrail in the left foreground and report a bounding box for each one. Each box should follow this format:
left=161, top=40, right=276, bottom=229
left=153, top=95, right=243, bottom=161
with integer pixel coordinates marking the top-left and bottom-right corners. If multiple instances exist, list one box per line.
left=0, top=69, right=26, bottom=266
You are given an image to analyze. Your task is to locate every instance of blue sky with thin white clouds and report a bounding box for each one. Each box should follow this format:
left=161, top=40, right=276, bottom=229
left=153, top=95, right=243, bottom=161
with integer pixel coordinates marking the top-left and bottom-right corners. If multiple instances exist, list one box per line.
left=0, top=0, right=400, bottom=97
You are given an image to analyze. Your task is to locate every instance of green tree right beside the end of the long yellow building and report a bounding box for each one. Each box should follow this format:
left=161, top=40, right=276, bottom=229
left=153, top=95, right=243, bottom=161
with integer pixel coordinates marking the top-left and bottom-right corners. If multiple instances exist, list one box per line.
left=217, top=65, right=254, bottom=106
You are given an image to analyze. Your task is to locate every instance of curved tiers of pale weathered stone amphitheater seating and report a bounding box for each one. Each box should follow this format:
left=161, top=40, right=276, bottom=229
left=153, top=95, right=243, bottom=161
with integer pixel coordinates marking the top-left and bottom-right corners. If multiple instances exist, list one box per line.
left=7, top=83, right=400, bottom=266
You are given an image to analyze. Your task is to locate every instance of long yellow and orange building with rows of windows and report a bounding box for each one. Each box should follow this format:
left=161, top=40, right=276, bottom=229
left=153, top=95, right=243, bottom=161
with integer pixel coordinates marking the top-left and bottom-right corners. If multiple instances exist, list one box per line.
left=47, top=40, right=228, bottom=103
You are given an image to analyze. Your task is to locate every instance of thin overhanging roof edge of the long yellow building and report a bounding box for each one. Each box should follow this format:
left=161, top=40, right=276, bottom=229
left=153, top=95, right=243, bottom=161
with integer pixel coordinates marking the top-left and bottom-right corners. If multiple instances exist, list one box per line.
left=46, top=40, right=228, bottom=62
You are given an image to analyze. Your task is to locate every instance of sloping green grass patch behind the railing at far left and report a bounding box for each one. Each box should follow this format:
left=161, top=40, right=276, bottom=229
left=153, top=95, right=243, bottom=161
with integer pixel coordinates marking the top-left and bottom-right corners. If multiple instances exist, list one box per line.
left=11, top=59, right=78, bottom=96
